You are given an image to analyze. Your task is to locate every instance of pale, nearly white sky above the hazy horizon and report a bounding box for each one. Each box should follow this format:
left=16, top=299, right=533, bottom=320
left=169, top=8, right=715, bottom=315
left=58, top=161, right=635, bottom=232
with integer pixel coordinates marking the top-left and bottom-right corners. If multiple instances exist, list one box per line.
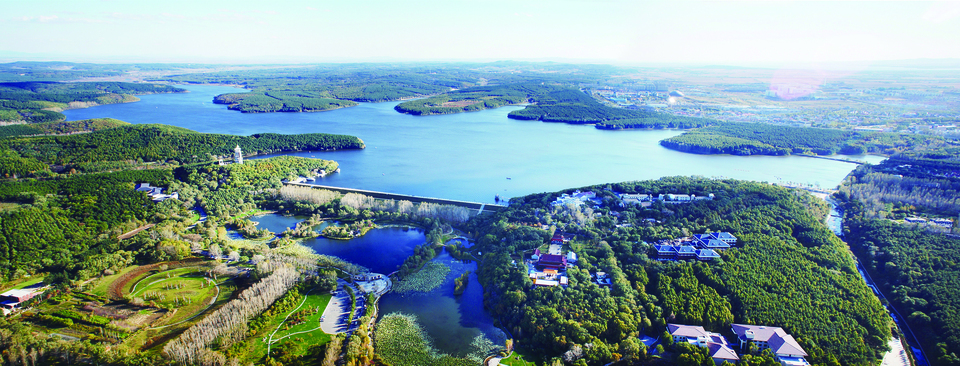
left=0, top=0, right=960, bottom=64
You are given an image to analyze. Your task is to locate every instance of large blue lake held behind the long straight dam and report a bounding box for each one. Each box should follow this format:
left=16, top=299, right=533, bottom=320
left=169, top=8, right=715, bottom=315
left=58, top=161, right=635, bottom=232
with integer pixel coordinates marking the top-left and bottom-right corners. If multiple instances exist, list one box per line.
left=64, top=85, right=878, bottom=203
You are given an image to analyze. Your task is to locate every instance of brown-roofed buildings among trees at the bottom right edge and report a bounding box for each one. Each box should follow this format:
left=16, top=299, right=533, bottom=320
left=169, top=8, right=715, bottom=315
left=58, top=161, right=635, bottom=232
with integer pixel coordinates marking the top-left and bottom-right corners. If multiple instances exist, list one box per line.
left=667, top=324, right=810, bottom=366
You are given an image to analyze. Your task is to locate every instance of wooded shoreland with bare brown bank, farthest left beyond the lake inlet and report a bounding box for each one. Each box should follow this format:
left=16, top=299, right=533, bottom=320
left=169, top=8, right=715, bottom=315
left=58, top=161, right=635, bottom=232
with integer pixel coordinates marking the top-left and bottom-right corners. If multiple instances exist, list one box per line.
left=0, top=81, right=186, bottom=123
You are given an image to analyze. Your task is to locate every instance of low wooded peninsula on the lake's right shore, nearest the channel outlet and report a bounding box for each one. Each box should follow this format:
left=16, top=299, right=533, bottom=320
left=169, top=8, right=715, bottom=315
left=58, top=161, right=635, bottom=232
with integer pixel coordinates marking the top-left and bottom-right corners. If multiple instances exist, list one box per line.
left=660, top=122, right=943, bottom=155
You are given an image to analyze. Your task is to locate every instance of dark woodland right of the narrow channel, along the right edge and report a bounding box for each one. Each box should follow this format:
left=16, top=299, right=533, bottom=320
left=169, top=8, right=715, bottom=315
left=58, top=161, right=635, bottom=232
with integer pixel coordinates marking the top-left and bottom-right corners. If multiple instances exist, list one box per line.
left=836, top=153, right=960, bottom=365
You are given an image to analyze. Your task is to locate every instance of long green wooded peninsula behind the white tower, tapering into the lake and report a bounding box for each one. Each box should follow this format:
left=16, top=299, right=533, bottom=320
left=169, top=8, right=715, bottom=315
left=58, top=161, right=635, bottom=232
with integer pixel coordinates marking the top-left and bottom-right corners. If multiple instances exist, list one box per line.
left=0, top=125, right=364, bottom=176
